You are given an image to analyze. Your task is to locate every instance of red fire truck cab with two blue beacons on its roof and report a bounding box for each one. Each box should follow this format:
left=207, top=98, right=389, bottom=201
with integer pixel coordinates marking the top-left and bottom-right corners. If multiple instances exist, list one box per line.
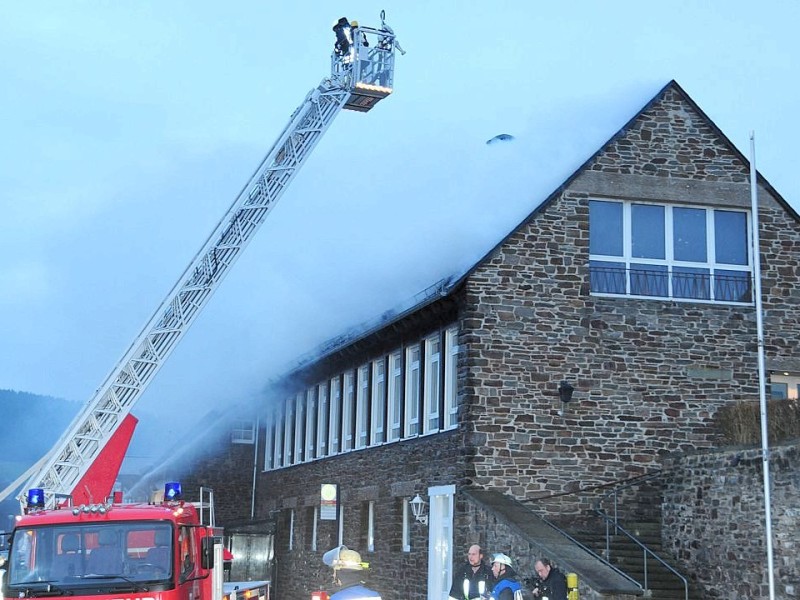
left=3, top=483, right=270, bottom=600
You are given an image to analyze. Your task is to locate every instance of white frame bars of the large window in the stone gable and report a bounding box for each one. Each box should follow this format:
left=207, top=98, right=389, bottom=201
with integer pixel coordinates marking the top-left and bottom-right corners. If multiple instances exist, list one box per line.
left=589, top=198, right=754, bottom=305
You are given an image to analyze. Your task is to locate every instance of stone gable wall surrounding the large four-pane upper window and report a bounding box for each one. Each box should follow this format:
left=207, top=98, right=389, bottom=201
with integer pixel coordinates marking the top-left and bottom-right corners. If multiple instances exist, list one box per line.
left=462, top=86, right=800, bottom=520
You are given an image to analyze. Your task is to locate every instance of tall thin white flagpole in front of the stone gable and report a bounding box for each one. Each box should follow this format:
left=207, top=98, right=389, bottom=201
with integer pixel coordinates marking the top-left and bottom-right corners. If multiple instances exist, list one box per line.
left=750, top=132, right=775, bottom=600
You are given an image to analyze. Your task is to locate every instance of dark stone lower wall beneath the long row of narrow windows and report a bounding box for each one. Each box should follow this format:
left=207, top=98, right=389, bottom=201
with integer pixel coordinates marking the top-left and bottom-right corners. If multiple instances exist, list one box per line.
left=256, top=431, right=464, bottom=600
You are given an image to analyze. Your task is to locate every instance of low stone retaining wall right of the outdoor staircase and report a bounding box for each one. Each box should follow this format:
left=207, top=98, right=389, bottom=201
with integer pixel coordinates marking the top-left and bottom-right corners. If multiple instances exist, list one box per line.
left=662, top=442, right=800, bottom=598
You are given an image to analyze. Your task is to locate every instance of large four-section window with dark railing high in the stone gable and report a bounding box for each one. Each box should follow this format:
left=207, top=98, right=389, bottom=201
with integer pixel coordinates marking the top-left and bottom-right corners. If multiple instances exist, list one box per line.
left=589, top=200, right=752, bottom=303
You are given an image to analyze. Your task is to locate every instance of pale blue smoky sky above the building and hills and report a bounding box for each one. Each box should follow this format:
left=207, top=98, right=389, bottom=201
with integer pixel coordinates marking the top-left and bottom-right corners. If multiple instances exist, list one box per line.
left=0, top=0, right=800, bottom=476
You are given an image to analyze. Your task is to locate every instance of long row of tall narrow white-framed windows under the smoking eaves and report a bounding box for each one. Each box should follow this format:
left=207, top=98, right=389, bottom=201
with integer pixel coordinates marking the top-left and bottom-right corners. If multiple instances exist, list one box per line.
left=264, top=326, right=458, bottom=470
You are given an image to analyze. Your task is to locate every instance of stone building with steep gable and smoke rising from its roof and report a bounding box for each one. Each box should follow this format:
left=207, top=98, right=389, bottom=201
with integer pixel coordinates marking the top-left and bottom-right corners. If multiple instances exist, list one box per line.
left=180, top=81, right=800, bottom=600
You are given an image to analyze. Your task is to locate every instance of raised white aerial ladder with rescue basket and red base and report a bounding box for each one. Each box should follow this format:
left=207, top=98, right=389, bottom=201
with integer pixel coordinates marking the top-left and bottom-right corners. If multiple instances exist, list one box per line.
left=0, top=11, right=405, bottom=508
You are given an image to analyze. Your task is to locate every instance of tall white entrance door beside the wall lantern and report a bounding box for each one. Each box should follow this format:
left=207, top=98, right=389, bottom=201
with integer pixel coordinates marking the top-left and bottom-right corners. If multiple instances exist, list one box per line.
left=428, top=485, right=456, bottom=600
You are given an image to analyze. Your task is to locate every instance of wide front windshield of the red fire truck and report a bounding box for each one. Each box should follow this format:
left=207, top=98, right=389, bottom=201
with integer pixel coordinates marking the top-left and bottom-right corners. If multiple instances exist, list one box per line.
left=5, top=521, right=174, bottom=597
